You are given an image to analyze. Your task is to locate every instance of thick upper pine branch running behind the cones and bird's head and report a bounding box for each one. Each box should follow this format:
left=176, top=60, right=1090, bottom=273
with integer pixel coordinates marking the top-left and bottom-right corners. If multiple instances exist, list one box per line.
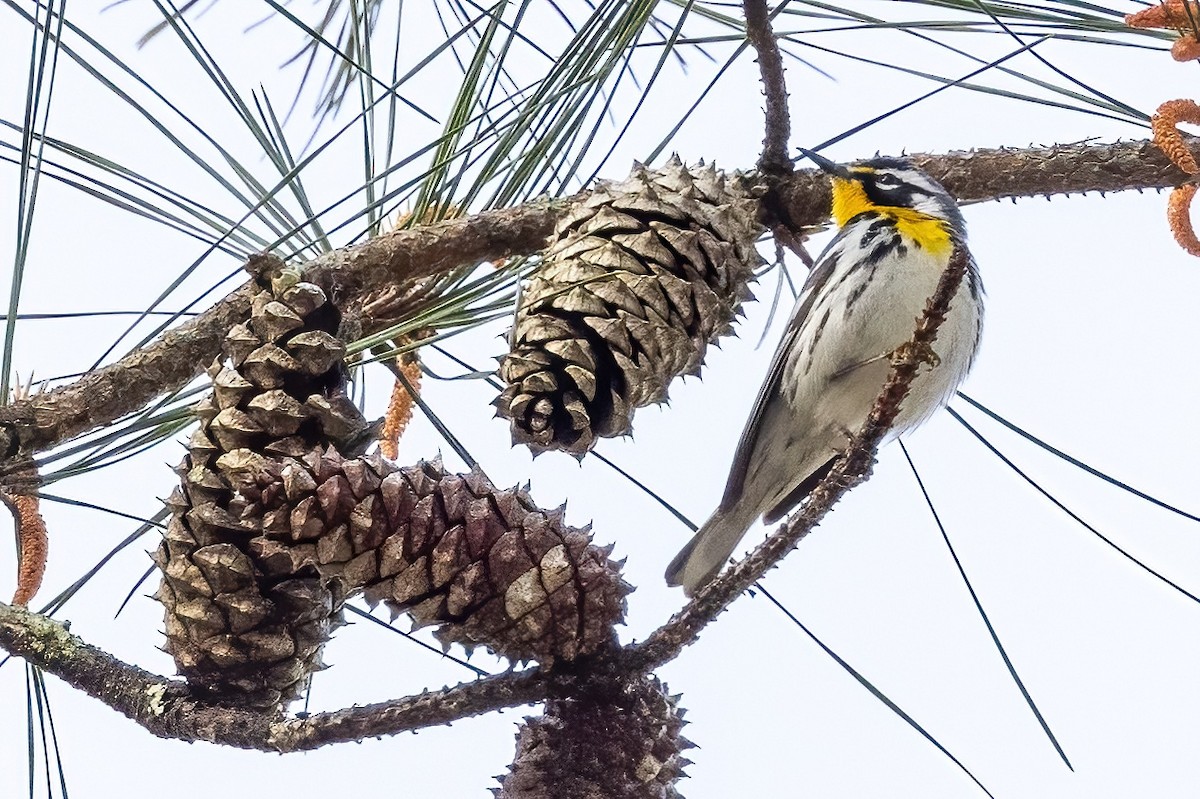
left=0, top=138, right=1194, bottom=467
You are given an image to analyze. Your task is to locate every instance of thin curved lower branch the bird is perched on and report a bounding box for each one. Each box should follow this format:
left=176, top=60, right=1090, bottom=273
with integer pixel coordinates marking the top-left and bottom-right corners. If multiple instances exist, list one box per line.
left=0, top=241, right=967, bottom=752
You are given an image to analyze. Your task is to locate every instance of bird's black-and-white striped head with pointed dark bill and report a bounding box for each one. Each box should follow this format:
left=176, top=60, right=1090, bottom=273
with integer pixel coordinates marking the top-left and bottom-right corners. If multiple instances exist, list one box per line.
left=803, top=150, right=966, bottom=236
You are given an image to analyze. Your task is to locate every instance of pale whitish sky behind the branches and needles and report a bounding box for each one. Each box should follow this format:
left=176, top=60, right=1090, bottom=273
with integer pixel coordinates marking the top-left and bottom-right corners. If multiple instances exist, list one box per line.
left=0, top=1, right=1200, bottom=799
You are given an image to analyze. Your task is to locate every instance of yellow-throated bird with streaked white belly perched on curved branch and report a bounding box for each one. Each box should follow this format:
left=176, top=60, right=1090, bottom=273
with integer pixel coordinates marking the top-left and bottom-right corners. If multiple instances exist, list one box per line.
left=666, top=149, right=983, bottom=596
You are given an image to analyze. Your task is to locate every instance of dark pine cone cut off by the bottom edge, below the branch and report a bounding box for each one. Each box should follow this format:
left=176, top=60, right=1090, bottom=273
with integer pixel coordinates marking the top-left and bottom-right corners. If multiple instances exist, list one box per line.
left=493, top=677, right=692, bottom=799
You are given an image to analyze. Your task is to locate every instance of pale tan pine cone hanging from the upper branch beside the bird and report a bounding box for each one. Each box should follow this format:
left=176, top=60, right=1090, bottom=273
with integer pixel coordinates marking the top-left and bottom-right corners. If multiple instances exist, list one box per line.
left=496, top=157, right=762, bottom=455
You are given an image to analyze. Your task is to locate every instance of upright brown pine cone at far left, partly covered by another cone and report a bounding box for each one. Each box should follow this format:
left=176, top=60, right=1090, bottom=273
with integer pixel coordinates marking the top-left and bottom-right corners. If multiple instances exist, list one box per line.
left=154, top=263, right=368, bottom=707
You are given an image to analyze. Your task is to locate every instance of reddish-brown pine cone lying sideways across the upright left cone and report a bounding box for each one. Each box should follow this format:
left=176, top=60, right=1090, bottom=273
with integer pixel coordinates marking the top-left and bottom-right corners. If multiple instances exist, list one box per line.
left=247, top=450, right=629, bottom=665
